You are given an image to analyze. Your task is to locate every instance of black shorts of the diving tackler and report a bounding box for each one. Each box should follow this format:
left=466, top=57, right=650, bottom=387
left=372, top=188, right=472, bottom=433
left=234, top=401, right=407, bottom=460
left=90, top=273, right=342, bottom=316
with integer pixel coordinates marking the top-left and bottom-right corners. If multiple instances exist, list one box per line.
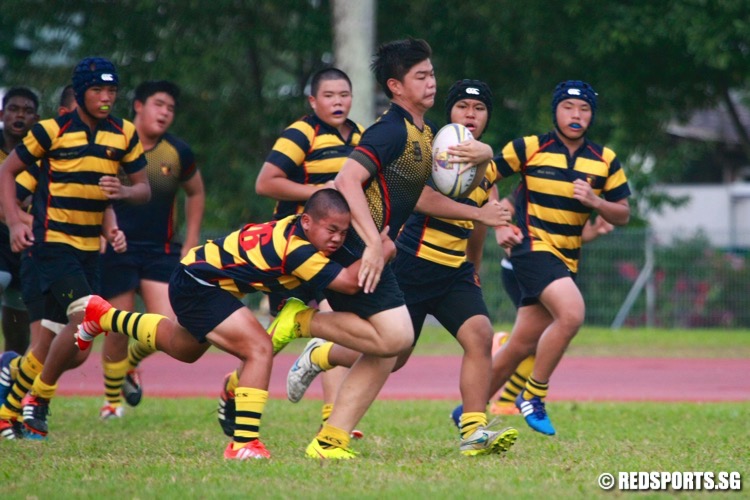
left=169, top=264, right=245, bottom=343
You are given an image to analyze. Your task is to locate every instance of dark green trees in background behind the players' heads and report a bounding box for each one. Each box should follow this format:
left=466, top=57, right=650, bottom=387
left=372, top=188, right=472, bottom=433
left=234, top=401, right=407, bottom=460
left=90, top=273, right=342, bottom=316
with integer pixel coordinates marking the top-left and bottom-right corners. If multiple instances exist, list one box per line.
left=0, top=0, right=750, bottom=228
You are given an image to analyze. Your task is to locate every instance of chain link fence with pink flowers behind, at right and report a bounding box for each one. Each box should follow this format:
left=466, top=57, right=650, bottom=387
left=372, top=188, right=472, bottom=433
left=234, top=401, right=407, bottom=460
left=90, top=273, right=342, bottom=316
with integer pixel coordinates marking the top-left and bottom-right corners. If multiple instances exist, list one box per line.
left=481, top=228, right=750, bottom=328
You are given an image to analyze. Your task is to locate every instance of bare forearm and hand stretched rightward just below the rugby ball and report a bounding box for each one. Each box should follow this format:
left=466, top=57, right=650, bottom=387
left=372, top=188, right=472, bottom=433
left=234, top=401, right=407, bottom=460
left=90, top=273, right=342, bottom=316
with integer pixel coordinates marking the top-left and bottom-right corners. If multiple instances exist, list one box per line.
left=415, top=186, right=510, bottom=226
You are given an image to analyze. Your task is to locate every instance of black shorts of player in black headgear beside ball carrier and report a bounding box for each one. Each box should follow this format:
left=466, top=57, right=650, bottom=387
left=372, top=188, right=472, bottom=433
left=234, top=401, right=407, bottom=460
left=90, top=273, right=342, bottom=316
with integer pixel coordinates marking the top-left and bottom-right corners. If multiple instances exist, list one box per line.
left=393, top=252, right=489, bottom=344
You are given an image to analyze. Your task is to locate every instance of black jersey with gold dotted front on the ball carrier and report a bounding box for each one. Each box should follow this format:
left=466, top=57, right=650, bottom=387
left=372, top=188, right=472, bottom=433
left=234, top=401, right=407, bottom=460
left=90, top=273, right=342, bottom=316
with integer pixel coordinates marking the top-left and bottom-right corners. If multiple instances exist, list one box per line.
left=344, top=103, right=437, bottom=256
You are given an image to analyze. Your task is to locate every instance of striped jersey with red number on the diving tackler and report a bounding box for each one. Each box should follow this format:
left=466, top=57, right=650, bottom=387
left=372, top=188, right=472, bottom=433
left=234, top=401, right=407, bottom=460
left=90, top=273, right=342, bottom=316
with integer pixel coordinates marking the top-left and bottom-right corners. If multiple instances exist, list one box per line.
left=182, top=215, right=343, bottom=297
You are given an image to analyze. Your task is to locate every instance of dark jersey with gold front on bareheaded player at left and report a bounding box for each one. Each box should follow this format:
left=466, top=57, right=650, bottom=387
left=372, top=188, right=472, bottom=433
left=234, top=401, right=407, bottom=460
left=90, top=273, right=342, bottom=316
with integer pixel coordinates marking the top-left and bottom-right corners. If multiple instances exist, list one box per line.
left=113, top=133, right=198, bottom=249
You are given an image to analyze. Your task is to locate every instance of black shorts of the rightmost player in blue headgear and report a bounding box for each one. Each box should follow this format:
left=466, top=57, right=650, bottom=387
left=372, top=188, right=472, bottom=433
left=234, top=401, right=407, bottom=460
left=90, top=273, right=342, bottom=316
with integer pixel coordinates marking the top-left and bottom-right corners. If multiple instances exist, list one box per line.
left=510, top=252, right=576, bottom=307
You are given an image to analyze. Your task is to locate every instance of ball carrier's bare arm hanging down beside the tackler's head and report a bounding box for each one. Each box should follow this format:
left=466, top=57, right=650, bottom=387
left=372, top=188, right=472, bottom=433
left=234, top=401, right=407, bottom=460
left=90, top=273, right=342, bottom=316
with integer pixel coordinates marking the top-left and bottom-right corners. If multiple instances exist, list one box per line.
left=334, top=158, right=385, bottom=293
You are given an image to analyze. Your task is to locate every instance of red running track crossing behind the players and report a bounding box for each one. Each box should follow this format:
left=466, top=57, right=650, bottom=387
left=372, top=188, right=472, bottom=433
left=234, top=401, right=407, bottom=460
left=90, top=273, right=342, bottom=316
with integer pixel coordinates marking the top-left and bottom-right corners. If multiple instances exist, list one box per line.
left=58, top=352, right=750, bottom=402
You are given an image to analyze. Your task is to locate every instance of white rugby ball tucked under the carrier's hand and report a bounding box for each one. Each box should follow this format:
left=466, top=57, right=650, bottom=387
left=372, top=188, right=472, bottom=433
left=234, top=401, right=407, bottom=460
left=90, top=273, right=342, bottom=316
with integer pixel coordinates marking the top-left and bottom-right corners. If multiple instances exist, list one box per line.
left=432, top=123, right=477, bottom=198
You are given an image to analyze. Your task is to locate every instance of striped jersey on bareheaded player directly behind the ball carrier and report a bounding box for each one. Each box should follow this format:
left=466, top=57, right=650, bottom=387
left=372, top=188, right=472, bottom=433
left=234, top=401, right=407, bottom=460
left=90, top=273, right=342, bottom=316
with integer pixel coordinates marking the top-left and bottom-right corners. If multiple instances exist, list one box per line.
left=266, top=113, right=363, bottom=219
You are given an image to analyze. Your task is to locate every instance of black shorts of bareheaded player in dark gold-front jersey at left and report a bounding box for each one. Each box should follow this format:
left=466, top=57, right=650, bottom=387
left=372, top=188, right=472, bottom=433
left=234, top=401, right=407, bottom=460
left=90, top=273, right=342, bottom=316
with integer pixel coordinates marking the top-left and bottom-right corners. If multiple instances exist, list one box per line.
left=100, top=243, right=180, bottom=299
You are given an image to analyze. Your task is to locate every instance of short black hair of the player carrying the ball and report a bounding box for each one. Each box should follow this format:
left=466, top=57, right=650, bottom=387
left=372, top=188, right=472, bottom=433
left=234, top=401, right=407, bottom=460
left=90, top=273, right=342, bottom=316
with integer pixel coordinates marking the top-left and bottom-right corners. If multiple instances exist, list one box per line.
left=370, top=37, right=432, bottom=99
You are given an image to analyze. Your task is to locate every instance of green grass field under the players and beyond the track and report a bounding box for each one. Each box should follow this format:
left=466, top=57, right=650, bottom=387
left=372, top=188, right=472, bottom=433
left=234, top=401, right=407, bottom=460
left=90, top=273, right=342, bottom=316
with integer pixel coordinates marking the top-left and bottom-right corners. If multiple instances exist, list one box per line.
left=0, top=330, right=750, bottom=499
